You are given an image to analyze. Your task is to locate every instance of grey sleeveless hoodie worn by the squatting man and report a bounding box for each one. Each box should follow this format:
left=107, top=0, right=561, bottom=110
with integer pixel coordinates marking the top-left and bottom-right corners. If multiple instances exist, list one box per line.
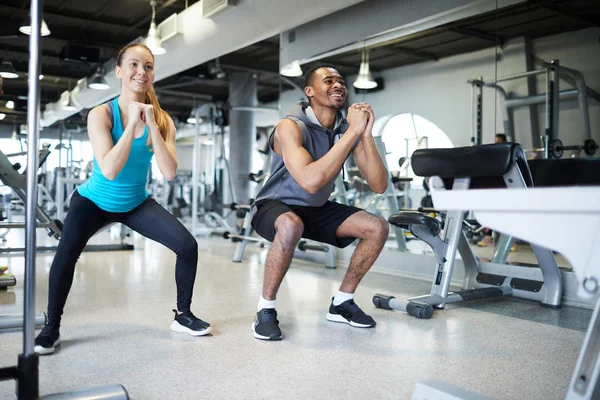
left=251, top=101, right=348, bottom=215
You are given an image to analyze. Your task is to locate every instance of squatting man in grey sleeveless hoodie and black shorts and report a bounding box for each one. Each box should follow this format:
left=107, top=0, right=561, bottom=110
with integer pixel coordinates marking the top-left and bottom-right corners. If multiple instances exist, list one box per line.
left=251, top=66, right=388, bottom=340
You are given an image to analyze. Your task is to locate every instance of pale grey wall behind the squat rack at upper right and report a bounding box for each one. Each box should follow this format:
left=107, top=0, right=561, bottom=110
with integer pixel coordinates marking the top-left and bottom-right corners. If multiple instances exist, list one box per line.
left=342, top=28, right=600, bottom=147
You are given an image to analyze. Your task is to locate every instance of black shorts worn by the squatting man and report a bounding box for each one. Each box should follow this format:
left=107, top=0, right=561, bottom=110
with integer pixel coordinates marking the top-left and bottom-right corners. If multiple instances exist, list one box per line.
left=252, top=200, right=362, bottom=248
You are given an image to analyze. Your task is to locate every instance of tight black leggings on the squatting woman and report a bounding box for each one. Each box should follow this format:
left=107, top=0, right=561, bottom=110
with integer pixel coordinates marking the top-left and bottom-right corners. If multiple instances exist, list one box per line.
left=48, top=191, right=198, bottom=326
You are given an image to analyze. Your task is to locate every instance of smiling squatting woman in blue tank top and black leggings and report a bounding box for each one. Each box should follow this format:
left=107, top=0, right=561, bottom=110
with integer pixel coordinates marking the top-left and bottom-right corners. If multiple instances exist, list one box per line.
left=35, top=43, right=211, bottom=354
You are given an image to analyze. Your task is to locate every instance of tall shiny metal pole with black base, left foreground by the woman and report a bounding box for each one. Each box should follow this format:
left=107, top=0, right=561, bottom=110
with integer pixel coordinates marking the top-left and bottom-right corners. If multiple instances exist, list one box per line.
left=17, top=0, right=43, bottom=398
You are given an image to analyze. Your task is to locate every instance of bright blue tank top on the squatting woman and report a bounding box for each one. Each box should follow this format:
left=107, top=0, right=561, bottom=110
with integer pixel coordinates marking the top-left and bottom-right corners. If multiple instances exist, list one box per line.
left=77, top=97, right=154, bottom=212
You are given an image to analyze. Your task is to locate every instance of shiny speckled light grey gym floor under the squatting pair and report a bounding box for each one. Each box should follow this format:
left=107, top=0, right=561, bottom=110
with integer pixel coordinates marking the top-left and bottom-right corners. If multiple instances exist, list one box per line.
left=0, top=229, right=591, bottom=400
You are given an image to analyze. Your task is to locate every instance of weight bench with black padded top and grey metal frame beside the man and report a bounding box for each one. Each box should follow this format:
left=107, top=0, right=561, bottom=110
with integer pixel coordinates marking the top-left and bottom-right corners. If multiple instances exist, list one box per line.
left=373, top=143, right=562, bottom=318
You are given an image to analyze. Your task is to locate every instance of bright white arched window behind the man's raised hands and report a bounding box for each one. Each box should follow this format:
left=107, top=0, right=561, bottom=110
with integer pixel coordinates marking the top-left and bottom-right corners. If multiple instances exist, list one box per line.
left=380, top=113, right=454, bottom=178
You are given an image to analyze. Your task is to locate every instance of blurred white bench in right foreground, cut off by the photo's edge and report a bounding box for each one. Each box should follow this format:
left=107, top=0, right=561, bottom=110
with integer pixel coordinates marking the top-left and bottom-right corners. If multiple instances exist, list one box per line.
left=412, top=155, right=600, bottom=400
